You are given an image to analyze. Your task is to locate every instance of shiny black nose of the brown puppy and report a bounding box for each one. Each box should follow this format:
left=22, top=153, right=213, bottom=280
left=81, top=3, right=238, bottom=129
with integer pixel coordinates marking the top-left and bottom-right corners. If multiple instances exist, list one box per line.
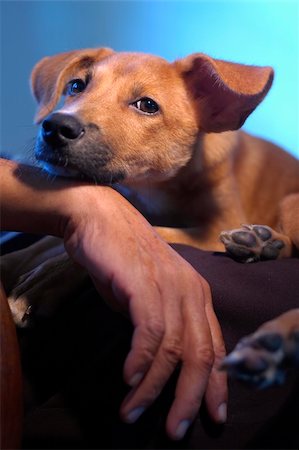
left=42, top=113, right=84, bottom=145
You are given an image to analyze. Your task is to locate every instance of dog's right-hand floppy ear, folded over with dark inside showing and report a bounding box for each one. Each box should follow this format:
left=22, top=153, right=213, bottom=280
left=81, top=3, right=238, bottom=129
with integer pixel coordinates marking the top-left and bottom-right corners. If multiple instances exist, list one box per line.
left=174, top=53, right=274, bottom=132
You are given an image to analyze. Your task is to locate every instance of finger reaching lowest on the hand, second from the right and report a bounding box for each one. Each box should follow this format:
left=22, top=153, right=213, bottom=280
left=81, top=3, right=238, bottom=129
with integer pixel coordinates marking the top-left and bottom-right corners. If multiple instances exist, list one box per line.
left=166, top=284, right=214, bottom=440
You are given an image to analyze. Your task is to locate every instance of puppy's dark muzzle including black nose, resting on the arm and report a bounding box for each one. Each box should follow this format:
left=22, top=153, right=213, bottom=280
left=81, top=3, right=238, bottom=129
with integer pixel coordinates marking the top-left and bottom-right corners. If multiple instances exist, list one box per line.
left=35, top=112, right=124, bottom=184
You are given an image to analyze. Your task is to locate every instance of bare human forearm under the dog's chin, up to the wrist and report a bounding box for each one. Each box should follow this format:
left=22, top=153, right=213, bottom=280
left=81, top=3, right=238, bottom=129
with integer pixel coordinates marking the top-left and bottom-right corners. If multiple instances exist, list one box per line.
left=0, top=159, right=104, bottom=237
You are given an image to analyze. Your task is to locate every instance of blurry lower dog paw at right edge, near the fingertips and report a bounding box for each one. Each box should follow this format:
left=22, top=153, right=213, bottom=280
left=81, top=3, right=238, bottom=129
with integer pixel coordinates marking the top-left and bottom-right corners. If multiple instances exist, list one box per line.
left=221, top=309, right=299, bottom=389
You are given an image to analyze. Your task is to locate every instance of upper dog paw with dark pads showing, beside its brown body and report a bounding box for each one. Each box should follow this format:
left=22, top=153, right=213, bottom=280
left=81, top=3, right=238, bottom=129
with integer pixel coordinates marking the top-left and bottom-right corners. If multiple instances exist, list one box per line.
left=220, top=225, right=291, bottom=263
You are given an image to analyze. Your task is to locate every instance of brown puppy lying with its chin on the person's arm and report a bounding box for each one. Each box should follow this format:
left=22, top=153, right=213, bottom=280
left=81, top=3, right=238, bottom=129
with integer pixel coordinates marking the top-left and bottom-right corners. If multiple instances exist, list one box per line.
left=2, top=48, right=299, bottom=383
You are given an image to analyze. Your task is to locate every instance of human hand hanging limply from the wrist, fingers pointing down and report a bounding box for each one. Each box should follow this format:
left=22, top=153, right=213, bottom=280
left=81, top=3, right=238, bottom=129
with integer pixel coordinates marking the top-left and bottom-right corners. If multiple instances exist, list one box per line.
left=64, top=186, right=227, bottom=439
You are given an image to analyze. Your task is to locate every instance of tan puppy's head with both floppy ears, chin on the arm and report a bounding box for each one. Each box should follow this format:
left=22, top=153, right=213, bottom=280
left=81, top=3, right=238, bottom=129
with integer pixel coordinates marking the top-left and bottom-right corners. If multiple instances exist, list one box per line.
left=31, top=48, right=273, bottom=184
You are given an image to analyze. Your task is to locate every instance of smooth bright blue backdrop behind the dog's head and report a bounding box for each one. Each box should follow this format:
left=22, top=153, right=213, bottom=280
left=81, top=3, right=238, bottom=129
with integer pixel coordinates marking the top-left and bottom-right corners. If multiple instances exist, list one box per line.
left=1, top=0, right=299, bottom=159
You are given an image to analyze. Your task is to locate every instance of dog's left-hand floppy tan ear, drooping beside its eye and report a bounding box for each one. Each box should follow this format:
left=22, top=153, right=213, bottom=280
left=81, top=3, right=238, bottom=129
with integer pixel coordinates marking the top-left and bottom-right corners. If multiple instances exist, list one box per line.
left=31, top=48, right=114, bottom=123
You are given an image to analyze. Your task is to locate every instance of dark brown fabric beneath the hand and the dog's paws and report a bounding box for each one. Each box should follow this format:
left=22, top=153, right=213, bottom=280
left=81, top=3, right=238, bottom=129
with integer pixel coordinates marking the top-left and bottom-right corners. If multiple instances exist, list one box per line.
left=2, top=237, right=299, bottom=449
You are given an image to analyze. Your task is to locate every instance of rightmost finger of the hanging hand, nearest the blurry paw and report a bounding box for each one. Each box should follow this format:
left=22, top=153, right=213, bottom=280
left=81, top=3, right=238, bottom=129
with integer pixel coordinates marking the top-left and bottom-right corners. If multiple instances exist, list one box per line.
left=205, top=303, right=228, bottom=423
